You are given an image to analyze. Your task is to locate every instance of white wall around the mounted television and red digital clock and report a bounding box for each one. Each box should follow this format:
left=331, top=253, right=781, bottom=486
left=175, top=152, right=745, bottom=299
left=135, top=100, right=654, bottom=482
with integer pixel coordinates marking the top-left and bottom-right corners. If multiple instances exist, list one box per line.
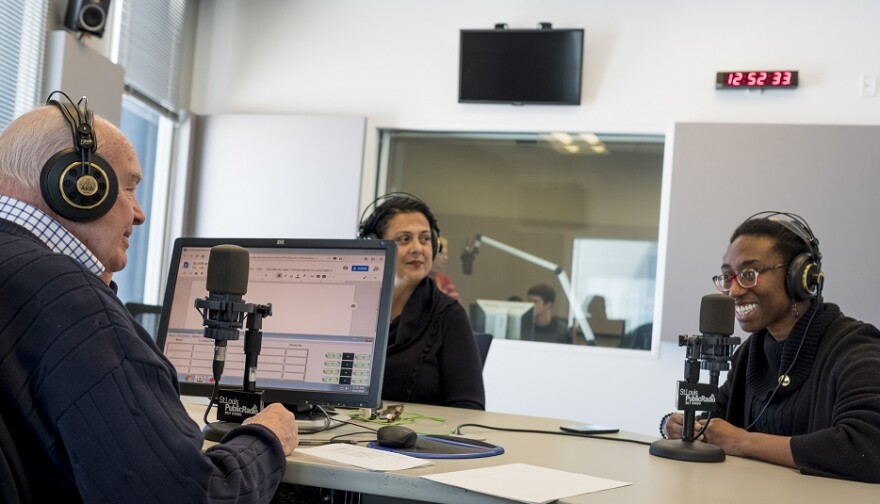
left=192, top=0, right=880, bottom=433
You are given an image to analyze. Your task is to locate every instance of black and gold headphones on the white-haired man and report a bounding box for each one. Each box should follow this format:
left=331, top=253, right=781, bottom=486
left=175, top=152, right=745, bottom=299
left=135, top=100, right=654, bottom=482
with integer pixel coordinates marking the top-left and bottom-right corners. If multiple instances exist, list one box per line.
left=40, top=91, right=119, bottom=221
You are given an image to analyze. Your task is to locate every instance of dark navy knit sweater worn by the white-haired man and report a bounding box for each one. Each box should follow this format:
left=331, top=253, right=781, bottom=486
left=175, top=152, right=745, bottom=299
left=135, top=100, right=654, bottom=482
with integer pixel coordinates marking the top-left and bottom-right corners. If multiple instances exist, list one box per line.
left=0, top=220, right=285, bottom=503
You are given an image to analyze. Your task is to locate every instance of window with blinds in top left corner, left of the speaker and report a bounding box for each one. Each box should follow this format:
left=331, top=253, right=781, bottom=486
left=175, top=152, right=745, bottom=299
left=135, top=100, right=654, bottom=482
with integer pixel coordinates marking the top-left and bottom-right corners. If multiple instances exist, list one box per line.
left=0, top=0, right=49, bottom=130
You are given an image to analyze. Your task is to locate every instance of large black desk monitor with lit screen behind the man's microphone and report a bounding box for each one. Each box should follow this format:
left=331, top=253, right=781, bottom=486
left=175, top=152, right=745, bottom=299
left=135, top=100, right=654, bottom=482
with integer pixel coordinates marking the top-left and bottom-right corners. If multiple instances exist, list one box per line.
left=157, top=238, right=397, bottom=408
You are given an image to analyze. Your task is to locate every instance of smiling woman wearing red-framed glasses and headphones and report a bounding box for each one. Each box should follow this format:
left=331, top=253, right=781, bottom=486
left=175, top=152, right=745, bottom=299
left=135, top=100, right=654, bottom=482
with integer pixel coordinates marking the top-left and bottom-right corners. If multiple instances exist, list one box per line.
left=660, top=211, right=880, bottom=483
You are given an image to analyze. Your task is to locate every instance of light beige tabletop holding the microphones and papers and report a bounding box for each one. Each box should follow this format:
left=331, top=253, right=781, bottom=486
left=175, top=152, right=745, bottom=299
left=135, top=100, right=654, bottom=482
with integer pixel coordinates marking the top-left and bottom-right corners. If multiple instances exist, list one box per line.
left=187, top=404, right=880, bottom=504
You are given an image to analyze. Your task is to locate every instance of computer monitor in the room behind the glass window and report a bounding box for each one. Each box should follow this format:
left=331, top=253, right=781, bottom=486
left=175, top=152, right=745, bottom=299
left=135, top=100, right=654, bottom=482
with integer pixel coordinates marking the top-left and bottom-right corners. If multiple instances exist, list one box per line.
left=470, top=299, right=535, bottom=341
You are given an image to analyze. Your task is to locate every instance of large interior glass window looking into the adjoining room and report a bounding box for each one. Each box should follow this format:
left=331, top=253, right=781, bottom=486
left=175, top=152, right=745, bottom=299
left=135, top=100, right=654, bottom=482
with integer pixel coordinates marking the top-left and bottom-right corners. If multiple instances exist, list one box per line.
left=377, top=130, right=663, bottom=350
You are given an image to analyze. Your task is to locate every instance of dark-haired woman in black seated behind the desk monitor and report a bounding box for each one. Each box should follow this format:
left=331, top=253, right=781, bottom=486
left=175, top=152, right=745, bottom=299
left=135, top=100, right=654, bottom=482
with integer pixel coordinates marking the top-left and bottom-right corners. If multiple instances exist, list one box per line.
left=359, top=193, right=486, bottom=409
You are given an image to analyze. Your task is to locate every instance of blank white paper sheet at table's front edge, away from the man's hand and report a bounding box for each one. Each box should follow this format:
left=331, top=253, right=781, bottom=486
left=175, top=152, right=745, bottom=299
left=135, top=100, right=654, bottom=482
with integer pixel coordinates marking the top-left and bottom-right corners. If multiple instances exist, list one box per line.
left=422, top=464, right=632, bottom=504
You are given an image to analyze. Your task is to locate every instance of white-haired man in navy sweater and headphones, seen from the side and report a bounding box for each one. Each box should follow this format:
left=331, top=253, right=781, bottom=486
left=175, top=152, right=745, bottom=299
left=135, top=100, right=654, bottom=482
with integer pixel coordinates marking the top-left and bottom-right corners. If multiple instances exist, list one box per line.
left=0, top=92, right=298, bottom=502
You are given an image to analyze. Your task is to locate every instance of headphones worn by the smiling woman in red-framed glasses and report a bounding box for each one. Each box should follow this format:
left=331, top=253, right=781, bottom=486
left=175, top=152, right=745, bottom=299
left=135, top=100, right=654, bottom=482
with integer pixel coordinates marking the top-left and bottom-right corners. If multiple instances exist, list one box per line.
left=746, top=210, right=825, bottom=301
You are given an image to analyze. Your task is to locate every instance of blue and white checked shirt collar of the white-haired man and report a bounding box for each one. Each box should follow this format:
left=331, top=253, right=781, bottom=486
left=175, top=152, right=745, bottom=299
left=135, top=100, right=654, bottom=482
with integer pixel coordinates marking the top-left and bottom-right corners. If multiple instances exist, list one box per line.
left=0, top=194, right=104, bottom=276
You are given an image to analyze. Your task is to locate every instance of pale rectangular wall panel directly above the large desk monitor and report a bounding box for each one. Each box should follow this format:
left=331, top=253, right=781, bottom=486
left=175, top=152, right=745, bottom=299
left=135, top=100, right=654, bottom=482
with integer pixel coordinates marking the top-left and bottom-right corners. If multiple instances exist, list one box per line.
left=188, top=114, right=365, bottom=238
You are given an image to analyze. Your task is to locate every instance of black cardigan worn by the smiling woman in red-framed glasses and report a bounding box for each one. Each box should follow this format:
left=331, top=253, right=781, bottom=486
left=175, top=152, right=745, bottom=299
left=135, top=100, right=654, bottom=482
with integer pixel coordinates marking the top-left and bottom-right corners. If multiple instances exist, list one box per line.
left=718, top=302, right=880, bottom=483
